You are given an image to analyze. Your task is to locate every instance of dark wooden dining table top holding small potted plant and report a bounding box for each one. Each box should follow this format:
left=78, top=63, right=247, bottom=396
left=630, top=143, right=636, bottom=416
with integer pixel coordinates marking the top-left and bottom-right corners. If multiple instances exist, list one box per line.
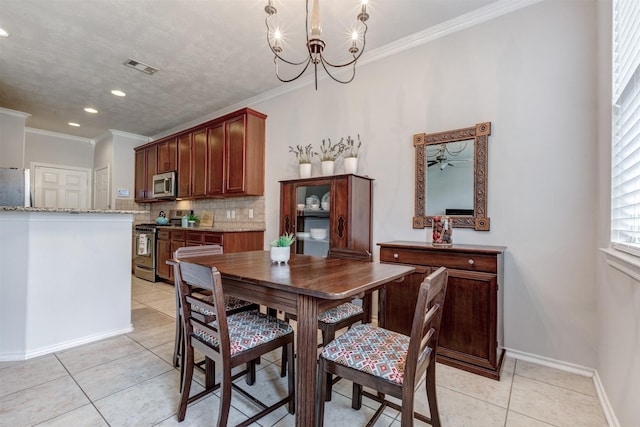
left=180, top=251, right=415, bottom=300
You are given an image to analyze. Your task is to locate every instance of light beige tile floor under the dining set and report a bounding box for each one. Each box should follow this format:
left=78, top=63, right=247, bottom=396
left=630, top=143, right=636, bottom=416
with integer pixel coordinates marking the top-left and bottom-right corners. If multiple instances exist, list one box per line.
left=0, top=277, right=607, bottom=427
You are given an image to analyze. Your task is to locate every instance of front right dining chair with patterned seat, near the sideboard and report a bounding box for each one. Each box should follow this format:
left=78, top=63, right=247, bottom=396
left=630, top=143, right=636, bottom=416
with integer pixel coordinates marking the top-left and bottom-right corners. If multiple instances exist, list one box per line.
left=317, top=267, right=448, bottom=427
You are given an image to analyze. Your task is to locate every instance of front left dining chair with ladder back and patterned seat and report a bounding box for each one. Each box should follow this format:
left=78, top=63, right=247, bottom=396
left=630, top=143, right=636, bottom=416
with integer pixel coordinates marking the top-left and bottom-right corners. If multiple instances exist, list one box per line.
left=177, top=260, right=295, bottom=426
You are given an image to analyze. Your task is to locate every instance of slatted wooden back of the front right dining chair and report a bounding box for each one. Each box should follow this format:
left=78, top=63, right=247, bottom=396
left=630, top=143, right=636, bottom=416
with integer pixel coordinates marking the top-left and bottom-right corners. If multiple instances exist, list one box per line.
left=404, top=267, right=448, bottom=386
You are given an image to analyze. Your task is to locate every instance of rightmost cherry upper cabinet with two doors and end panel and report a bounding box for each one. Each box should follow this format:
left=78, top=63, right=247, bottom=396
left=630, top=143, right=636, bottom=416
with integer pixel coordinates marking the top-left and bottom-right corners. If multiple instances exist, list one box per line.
left=207, top=108, right=267, bottom=197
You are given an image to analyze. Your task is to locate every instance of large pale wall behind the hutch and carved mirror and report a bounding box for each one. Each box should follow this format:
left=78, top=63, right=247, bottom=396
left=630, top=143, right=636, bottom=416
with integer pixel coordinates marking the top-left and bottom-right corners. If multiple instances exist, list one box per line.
left=253, top=1, right=597, bottom=367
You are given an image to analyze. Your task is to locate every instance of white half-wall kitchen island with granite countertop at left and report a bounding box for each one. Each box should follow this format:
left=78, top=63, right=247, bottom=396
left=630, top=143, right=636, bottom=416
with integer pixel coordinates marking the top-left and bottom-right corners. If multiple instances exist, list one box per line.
left=0, top=206, right=144, bottom=361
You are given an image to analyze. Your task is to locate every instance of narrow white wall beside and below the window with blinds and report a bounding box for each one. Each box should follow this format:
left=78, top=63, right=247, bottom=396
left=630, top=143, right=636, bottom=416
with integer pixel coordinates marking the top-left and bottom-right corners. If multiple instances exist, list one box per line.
left=596, top=1, right=640, bottom=426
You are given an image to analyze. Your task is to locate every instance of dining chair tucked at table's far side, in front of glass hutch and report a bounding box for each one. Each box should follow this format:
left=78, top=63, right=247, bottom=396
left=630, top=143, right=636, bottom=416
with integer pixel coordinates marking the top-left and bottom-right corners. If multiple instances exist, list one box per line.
left=280, top=248, right=371, bottom=401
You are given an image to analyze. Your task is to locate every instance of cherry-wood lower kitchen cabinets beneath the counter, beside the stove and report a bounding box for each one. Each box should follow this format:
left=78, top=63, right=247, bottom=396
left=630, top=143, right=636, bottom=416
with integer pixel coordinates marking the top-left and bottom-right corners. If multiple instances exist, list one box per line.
left=156, top=228, right=264, bottom=283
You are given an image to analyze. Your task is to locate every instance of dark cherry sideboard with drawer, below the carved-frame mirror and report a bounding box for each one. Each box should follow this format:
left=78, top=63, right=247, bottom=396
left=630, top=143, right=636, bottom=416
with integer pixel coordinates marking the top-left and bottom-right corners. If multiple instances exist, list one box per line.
left=378, top=241, right=506, bottom=380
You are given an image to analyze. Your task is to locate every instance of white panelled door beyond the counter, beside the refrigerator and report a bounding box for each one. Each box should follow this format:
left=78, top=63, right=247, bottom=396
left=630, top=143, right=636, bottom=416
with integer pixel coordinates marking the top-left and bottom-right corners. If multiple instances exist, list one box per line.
left=31, top=163, right=91, bottom=209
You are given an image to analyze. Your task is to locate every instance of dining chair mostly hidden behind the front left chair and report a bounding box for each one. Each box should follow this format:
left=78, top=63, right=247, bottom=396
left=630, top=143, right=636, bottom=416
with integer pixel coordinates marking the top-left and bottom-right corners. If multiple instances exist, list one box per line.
left=170, top=245, right=260, bottom=387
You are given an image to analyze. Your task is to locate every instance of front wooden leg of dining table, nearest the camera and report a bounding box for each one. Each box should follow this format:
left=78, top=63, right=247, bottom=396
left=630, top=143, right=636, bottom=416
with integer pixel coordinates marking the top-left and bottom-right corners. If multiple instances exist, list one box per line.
left=296, top=295, right=318, bottom=427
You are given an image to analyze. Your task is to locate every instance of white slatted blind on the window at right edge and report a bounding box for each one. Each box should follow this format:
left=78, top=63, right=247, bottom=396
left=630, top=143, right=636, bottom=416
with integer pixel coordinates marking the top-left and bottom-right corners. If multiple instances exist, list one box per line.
left=611, top=0, right=640, bottom=256
